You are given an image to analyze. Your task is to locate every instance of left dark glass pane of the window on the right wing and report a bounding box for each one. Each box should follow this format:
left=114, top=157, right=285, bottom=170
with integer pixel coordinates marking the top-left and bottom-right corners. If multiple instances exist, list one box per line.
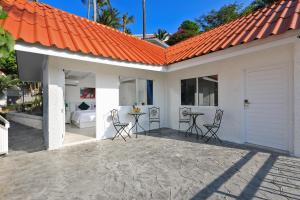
left=181, top=78, right=197, bottom=105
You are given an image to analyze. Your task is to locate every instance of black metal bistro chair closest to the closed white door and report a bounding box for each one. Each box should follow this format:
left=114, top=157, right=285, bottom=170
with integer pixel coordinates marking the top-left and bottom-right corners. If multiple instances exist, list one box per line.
left=202, top=109, right=224, bottom=143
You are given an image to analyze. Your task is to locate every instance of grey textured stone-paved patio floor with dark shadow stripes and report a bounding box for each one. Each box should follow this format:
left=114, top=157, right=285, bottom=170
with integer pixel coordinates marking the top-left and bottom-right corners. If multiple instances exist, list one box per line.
left=0, top=129, right=300, bottom=200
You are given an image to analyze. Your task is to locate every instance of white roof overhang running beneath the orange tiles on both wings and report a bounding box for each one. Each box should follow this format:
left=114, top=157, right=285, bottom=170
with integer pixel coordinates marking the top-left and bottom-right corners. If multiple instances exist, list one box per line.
left=15, top=30, right=300, bottom=80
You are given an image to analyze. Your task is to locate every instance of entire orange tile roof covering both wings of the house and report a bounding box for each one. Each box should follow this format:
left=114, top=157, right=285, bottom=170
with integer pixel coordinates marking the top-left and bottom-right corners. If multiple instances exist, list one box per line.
left=0, top=0, right=300, bottom=65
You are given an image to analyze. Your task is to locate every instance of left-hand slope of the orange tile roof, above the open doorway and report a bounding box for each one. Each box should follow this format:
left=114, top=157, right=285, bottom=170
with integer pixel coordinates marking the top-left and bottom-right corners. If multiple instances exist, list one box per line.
left=0, top=0, right=165, bottom=65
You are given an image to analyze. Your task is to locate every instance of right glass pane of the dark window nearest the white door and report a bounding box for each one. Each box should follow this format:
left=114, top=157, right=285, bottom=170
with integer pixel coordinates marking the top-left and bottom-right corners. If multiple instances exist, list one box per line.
left=198, top=75, right=218, bottom=106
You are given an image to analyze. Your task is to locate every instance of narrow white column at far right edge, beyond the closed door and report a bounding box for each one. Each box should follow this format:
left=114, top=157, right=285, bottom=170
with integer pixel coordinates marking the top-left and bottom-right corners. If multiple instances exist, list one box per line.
left=294, top=40, right=300, bottom=157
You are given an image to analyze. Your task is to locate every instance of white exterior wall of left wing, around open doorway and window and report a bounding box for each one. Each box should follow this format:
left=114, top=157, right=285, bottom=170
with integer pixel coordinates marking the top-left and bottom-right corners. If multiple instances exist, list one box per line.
left=48, top=57, right=168, bottom=144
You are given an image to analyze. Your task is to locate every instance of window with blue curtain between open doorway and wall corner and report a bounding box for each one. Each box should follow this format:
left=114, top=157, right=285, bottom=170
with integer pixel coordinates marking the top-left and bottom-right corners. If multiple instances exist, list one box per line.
left=119, top=77, right=153, bottom=106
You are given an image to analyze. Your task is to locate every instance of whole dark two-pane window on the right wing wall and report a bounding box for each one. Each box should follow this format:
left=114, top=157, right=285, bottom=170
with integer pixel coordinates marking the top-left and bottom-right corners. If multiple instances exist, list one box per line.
left=181, top=75, right=218, bottom=106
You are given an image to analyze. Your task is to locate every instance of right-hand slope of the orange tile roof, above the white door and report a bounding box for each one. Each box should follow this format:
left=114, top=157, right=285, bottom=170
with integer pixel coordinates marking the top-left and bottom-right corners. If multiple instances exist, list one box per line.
left=166, top=0, right=300, bottom=64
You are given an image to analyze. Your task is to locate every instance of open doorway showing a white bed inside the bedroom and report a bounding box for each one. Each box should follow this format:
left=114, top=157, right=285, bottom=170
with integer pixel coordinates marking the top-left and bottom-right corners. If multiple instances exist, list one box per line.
left=64, top=70, right=96, bottom=146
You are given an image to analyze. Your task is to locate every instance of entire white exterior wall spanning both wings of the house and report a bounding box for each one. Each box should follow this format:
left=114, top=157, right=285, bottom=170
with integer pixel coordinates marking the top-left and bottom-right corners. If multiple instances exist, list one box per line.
left=44, top=41, right=300, bottom=155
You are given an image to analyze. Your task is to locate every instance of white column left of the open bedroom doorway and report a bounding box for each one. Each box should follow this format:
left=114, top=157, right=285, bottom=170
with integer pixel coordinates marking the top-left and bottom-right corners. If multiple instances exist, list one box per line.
left=43, top=57, right=65, bottom=150
